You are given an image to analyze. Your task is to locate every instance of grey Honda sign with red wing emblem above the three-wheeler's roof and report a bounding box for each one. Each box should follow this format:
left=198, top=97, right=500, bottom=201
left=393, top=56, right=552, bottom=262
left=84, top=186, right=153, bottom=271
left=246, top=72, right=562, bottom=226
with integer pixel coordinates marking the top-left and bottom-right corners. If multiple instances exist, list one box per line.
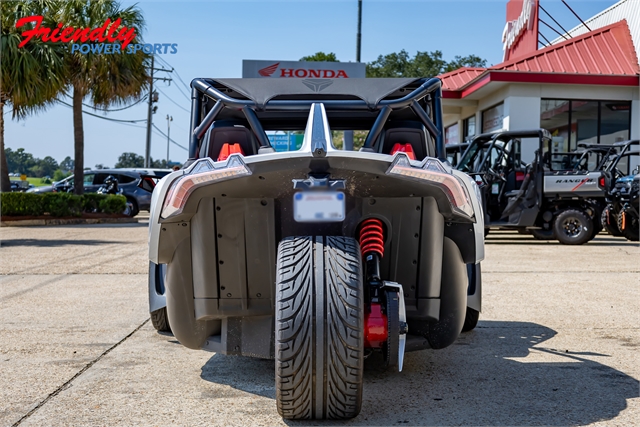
left=242, top=59, right=366, bottom=79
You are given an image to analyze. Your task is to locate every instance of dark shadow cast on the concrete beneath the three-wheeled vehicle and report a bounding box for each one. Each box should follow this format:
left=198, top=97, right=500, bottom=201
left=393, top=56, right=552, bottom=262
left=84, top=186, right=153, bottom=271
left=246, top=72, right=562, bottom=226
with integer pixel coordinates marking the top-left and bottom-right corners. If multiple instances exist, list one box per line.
left=201, top=321, right=639, bottom=426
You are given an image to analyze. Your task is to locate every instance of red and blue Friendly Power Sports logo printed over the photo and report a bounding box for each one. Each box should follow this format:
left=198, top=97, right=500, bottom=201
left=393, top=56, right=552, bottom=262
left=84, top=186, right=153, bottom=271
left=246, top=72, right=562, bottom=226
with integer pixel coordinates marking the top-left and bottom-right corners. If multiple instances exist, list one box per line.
left=16, top=15, right=178, bottom=55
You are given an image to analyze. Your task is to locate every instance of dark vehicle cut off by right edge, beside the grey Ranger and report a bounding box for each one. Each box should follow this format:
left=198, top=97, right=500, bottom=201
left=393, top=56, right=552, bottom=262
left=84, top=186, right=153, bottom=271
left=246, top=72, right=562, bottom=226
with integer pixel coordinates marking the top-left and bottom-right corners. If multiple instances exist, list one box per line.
left=598, top=139, right=640, bottom=241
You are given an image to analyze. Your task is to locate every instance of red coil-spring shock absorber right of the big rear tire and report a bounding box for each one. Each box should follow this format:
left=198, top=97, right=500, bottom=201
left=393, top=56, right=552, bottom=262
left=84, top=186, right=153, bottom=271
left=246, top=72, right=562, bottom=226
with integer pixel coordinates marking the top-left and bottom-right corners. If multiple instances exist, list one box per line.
left=358, top=218, right=388, bottom=348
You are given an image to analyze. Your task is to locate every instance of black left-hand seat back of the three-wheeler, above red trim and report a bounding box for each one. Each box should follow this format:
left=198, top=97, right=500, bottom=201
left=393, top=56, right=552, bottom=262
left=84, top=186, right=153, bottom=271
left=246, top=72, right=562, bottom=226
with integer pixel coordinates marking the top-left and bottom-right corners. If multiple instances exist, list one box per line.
left=198, top=120, right=258, bottom=160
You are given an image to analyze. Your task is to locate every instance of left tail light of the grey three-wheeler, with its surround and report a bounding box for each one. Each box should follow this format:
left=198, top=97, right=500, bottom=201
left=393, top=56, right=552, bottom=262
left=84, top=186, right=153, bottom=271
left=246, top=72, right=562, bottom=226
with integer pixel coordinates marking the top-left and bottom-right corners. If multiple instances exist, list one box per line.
left=162, top=155, right=251, bottom=219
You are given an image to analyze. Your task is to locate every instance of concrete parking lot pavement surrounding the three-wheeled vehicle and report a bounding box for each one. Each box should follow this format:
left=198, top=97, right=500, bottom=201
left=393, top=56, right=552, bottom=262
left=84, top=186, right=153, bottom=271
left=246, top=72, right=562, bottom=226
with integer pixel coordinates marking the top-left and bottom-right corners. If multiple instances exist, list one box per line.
left=0, top=220, right=640, bottom=426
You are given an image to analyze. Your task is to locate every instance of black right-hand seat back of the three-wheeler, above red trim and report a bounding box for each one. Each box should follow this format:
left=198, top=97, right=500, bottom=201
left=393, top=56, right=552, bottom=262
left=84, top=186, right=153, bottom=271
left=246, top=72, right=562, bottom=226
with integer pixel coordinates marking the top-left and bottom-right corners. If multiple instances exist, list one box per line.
left=380, top=121, right=435, bottom=160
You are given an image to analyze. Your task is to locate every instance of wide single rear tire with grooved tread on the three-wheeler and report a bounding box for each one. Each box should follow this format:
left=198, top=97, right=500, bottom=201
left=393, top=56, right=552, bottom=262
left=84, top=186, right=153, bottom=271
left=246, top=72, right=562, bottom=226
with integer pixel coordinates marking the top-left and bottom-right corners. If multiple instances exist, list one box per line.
left=275, top=237, right=364, bottom=419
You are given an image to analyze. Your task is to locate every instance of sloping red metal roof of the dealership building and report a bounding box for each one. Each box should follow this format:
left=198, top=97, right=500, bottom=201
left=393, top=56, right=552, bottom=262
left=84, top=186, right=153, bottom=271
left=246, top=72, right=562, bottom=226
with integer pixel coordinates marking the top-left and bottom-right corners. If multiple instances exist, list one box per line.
left=439, top=19, right=640, bottom=98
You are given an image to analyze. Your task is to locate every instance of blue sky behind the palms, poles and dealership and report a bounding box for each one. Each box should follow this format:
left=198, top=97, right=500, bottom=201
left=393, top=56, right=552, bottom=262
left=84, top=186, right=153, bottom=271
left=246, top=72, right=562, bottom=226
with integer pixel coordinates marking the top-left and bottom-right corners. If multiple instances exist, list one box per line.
left=5, top=0, right=615, bottom=171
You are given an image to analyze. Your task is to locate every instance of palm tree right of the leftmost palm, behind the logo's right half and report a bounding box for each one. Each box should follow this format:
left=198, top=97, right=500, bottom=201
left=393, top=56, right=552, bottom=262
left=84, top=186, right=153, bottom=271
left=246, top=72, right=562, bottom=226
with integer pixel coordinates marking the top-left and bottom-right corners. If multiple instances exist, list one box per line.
left=58, top=0, right=150, bottom=194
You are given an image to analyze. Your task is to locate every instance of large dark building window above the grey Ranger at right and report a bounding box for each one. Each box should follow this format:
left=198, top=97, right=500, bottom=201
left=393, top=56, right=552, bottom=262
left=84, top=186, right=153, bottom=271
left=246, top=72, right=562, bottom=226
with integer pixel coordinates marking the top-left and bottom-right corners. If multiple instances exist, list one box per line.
left=540, top=99, right=631, bottom=152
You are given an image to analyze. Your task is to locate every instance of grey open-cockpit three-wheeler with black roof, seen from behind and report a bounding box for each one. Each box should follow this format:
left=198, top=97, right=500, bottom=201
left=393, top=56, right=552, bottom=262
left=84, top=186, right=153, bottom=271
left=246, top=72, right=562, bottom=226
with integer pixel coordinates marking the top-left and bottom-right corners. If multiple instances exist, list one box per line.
left=149, top=79, right=484, bottom=419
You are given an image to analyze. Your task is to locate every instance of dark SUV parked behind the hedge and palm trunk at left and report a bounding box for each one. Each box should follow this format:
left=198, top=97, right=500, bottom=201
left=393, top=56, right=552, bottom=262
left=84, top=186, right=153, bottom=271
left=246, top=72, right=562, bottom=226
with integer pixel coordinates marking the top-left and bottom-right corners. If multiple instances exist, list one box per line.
left=29, top=169, right=172, bottom=216
